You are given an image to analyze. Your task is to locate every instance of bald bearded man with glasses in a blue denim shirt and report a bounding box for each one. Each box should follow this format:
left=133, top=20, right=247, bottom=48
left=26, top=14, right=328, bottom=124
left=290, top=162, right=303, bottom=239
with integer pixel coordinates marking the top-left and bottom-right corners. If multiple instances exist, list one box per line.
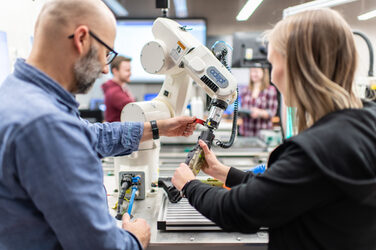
left=0, top=0, right=198, bottom=250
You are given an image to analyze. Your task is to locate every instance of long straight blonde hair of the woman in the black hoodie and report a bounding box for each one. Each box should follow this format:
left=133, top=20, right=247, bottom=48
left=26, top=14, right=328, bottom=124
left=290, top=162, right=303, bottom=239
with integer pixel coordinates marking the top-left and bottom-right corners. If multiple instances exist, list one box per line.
left=268, top=9, right=363, bottom=132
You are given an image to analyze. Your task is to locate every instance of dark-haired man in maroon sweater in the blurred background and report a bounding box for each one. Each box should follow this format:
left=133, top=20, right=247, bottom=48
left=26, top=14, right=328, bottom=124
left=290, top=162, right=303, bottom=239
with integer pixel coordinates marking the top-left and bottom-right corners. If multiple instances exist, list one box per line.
left=102, top=56, right=136, bottom=122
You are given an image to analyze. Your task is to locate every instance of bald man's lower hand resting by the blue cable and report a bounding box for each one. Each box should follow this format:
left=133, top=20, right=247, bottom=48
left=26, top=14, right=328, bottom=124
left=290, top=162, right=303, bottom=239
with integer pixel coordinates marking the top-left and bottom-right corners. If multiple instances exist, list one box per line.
left=122, top=213, right=150, bottom=249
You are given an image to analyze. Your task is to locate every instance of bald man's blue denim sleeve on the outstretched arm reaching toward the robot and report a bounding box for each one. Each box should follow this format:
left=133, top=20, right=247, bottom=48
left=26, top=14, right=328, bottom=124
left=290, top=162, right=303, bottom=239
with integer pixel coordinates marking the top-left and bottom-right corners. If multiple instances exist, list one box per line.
left=80, top=118, right=144, bottom=157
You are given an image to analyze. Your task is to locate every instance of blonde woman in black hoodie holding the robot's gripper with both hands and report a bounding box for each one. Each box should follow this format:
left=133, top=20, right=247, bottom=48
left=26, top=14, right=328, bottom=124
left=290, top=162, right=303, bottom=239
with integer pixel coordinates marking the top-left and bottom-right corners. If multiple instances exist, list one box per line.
left=172, top=9, right=376, bottom=250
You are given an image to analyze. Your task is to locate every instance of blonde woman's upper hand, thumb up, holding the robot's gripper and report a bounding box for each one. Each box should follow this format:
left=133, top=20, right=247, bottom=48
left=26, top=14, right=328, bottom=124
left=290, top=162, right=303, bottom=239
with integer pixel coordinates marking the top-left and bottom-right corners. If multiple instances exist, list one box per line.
left=198, top=140, right=230, bottom=183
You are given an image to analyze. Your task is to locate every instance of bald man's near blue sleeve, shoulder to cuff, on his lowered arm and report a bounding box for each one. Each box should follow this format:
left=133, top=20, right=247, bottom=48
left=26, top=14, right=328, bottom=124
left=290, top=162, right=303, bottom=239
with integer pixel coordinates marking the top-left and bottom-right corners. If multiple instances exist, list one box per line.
left=15, top=115, right=142, bottom=249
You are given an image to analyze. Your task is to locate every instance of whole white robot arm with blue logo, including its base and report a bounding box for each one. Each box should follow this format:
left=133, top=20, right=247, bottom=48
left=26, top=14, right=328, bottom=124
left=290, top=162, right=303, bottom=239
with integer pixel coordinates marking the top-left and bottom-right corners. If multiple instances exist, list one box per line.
left=115, top=18, right=237, bottom=200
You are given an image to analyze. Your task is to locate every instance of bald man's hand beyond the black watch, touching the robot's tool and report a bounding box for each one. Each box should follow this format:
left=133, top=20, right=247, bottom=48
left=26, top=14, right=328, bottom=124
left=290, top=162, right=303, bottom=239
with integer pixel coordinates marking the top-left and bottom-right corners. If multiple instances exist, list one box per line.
left=157, top=116, right=196, bottom=137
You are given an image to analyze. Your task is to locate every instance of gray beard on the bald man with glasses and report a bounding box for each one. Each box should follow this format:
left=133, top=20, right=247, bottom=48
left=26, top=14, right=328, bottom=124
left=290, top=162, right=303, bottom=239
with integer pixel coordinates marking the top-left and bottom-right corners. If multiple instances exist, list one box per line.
left=73, top=46, right=102, bottom=94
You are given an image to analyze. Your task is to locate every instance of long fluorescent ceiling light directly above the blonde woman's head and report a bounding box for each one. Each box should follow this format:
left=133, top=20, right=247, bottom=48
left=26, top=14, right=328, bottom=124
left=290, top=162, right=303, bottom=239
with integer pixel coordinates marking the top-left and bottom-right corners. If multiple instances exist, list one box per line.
left=283, top=0, right=358, bottom=18
